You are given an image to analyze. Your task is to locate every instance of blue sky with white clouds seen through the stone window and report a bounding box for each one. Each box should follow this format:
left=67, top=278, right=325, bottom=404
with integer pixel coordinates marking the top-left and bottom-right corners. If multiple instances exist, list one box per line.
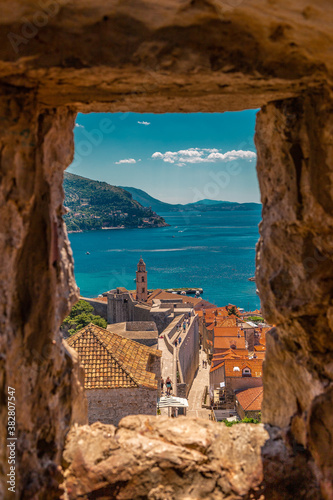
left=68, top=110, right=260, bottom=203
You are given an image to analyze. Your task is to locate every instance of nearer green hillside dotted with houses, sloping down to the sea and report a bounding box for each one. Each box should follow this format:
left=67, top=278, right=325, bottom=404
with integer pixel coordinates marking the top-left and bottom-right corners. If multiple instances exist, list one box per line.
left=64, top=172, right=167, bottom=232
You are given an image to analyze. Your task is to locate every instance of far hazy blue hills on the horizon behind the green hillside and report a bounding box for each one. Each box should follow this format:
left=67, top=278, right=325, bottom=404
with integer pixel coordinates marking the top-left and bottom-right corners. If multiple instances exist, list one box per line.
left=123, top=187, right=261, bottom=212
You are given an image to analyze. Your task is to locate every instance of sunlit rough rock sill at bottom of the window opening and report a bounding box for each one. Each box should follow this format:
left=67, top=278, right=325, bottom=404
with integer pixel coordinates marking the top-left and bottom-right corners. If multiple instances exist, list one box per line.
left=63, top=415, right=320, bottom=500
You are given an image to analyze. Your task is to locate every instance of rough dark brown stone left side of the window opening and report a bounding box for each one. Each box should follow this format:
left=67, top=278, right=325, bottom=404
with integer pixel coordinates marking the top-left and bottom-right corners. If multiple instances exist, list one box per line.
left=0, top=95, right=80, bottom=498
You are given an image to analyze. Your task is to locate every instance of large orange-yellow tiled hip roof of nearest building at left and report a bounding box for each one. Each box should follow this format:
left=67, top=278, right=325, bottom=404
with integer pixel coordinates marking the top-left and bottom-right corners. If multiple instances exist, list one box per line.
left=67, top=323, right=162, bottom=389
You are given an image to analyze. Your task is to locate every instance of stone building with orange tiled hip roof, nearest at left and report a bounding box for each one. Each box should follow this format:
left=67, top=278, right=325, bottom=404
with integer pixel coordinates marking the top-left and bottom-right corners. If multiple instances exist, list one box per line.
left=68, top=324, right=161, bottom=425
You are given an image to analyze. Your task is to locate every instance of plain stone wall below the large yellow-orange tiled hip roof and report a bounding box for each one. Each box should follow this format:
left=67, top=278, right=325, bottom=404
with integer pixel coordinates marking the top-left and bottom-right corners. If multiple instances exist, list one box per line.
left=86, top=387, right=157, bottom=425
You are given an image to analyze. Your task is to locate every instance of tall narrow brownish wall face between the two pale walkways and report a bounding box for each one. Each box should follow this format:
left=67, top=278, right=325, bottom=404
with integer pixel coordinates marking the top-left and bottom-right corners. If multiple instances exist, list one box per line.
left=178, top=316, right=200, bottom=390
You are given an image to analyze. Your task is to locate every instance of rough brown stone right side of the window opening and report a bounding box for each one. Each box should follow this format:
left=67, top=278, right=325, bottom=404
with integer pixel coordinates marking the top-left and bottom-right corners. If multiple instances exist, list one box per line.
left=256, top=88, right=333, bottom=498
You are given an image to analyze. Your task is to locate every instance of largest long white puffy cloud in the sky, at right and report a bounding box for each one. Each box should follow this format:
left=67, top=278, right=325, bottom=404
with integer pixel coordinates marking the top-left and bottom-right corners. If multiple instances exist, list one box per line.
left=152, top=148, right=257, bottom=167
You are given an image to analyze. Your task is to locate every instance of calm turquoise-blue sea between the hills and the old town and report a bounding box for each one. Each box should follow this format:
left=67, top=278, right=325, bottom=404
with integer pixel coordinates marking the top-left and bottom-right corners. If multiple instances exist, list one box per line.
left=69, top=210, right=261, bottom=310
